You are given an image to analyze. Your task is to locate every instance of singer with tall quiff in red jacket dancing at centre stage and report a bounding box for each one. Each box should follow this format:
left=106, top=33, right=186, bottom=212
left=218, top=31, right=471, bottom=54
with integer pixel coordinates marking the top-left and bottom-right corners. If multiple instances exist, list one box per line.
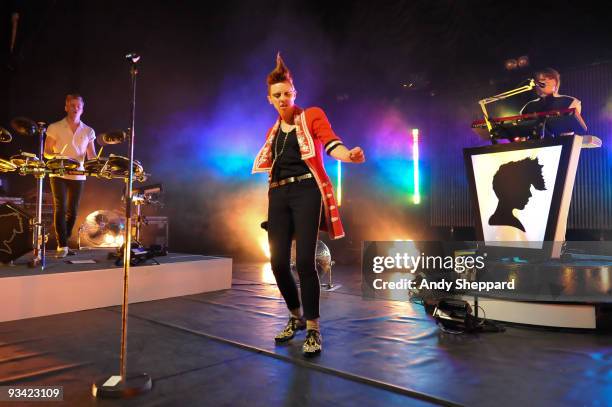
left=253, top=54, right=365, bottom=356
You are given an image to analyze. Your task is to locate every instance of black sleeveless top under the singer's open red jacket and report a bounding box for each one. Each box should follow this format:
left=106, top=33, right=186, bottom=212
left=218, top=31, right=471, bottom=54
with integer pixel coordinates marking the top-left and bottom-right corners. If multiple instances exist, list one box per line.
left=272, top=126, right=310, bottom=182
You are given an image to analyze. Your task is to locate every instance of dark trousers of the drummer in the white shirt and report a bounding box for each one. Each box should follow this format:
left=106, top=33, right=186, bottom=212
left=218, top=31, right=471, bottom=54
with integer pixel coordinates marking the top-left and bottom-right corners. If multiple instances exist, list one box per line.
left=50, top=177, right=85, bottom=247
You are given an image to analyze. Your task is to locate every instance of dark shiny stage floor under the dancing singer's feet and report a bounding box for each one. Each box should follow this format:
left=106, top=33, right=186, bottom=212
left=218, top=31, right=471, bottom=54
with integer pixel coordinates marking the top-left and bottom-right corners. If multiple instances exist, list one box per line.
left=0, top=264, right=612, bottom=406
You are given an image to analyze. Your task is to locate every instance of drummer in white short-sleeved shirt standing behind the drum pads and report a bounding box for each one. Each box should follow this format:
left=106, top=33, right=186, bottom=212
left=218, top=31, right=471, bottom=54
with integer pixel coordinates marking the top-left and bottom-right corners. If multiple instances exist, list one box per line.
left=45, top=93, right=96, bottom=257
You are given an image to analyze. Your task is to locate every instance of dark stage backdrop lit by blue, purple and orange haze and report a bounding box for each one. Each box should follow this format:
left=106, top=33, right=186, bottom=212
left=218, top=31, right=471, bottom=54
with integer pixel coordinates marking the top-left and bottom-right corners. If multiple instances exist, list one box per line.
left=0, top=0, right=612, bottom=257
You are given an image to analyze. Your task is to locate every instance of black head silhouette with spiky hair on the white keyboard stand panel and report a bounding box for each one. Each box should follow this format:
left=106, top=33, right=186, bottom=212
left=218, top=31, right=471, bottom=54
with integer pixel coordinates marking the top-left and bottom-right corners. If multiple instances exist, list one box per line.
left=489, top=158, right=546, bottom=232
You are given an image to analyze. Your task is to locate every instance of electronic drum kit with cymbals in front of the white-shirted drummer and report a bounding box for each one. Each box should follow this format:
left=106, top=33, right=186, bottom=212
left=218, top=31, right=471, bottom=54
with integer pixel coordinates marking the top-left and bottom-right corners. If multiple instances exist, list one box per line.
left=0, top=117, right=150, bottom=268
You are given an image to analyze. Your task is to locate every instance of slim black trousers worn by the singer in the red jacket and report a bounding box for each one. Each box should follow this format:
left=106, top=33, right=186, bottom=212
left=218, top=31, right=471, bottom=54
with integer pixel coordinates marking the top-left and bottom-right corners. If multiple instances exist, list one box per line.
left=268, top=178, right=321, bottom=319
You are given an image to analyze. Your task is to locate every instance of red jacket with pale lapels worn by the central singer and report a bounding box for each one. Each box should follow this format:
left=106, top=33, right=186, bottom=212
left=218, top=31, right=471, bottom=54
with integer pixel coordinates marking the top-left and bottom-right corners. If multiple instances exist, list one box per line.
left=253, top=106, right=344, bottom=239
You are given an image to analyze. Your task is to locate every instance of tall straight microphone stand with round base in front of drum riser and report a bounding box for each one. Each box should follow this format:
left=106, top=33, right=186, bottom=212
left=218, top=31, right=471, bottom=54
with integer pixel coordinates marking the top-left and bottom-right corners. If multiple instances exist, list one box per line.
left=92, top=53, right=153, bottom=398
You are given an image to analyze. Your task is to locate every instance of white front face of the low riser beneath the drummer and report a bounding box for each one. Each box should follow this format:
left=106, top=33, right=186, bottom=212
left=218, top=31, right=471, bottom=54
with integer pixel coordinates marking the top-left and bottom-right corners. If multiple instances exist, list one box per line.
left=0, top=258, right=232, bottom=322
